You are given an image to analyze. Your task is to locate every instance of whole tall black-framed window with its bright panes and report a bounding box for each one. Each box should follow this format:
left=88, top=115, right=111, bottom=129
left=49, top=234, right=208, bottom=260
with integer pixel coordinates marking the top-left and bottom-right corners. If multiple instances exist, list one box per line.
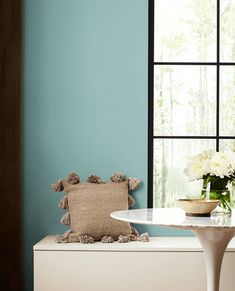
left=148, top=0, right=235, bottom=207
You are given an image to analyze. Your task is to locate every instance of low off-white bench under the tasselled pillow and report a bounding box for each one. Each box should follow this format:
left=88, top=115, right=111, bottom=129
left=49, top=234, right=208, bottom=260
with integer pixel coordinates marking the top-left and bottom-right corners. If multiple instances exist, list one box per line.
left=34, top=236, right=235, bottom=291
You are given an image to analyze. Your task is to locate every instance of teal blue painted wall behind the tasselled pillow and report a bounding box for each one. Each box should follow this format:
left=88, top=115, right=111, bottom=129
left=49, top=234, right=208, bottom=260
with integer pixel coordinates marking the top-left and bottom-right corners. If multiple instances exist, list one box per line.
left=22, top=0, right=189, bottom=291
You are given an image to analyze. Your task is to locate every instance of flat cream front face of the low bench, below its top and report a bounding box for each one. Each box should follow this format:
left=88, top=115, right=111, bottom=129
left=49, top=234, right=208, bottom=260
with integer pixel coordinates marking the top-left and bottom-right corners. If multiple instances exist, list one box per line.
left=34, top=251, right=207, bottom=291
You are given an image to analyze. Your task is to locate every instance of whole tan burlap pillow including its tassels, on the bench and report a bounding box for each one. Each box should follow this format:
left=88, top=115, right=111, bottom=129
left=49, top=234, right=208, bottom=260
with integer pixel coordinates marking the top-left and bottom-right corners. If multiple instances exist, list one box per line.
left=52, top=173, right=149, bottom=243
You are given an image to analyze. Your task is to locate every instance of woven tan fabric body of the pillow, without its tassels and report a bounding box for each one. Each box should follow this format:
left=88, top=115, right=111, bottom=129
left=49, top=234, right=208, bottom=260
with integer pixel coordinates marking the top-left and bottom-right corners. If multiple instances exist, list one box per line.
left=63, top=181, right=131, bottom=240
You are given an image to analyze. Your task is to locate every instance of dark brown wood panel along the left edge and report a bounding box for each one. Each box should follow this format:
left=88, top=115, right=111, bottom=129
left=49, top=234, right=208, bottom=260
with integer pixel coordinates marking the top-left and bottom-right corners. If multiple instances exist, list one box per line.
left=0, top=0, right=22, bottom=291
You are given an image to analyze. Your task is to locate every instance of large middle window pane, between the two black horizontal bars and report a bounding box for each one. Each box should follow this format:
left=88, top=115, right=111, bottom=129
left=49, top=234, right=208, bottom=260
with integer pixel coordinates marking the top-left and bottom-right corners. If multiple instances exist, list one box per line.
left=154, top=65, right=216, bottom=136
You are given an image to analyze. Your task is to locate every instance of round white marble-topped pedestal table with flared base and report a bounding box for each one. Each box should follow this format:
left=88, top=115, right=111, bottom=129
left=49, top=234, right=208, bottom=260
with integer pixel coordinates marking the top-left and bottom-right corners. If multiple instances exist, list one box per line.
left=111, top=208, right=235, bottom=291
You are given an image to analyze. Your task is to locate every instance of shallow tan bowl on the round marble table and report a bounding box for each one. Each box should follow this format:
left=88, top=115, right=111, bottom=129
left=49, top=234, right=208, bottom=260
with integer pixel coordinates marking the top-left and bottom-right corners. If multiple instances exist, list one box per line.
left=176, top=199, right=219, bottom=216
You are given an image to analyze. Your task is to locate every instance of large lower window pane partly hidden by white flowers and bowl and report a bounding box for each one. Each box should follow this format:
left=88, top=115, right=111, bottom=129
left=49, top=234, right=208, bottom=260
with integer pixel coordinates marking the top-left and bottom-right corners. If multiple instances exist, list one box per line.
left=153, top=139, right=215, bottom=207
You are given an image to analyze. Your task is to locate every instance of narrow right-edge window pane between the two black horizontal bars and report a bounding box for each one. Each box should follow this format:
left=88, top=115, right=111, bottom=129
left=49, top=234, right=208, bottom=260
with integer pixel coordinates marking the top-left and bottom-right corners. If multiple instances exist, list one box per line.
left=220, top=66, right=235, bottom=136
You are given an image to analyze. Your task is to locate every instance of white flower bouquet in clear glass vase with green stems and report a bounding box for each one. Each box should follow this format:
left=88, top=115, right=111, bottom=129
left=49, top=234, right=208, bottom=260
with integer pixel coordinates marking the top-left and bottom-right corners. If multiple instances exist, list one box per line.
left=185, top=151, right=235, bottom=213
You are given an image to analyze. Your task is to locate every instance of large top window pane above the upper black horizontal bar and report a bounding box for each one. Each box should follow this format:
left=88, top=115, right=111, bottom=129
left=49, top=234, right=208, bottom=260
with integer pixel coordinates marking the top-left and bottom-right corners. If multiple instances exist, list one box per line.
left=154, top=0, right=216, bottom=62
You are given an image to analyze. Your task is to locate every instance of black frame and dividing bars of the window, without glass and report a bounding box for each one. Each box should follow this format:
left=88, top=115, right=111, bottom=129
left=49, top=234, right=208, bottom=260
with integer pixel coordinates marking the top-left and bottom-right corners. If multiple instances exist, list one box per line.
left=147, top=0, right=235, bottom=208
